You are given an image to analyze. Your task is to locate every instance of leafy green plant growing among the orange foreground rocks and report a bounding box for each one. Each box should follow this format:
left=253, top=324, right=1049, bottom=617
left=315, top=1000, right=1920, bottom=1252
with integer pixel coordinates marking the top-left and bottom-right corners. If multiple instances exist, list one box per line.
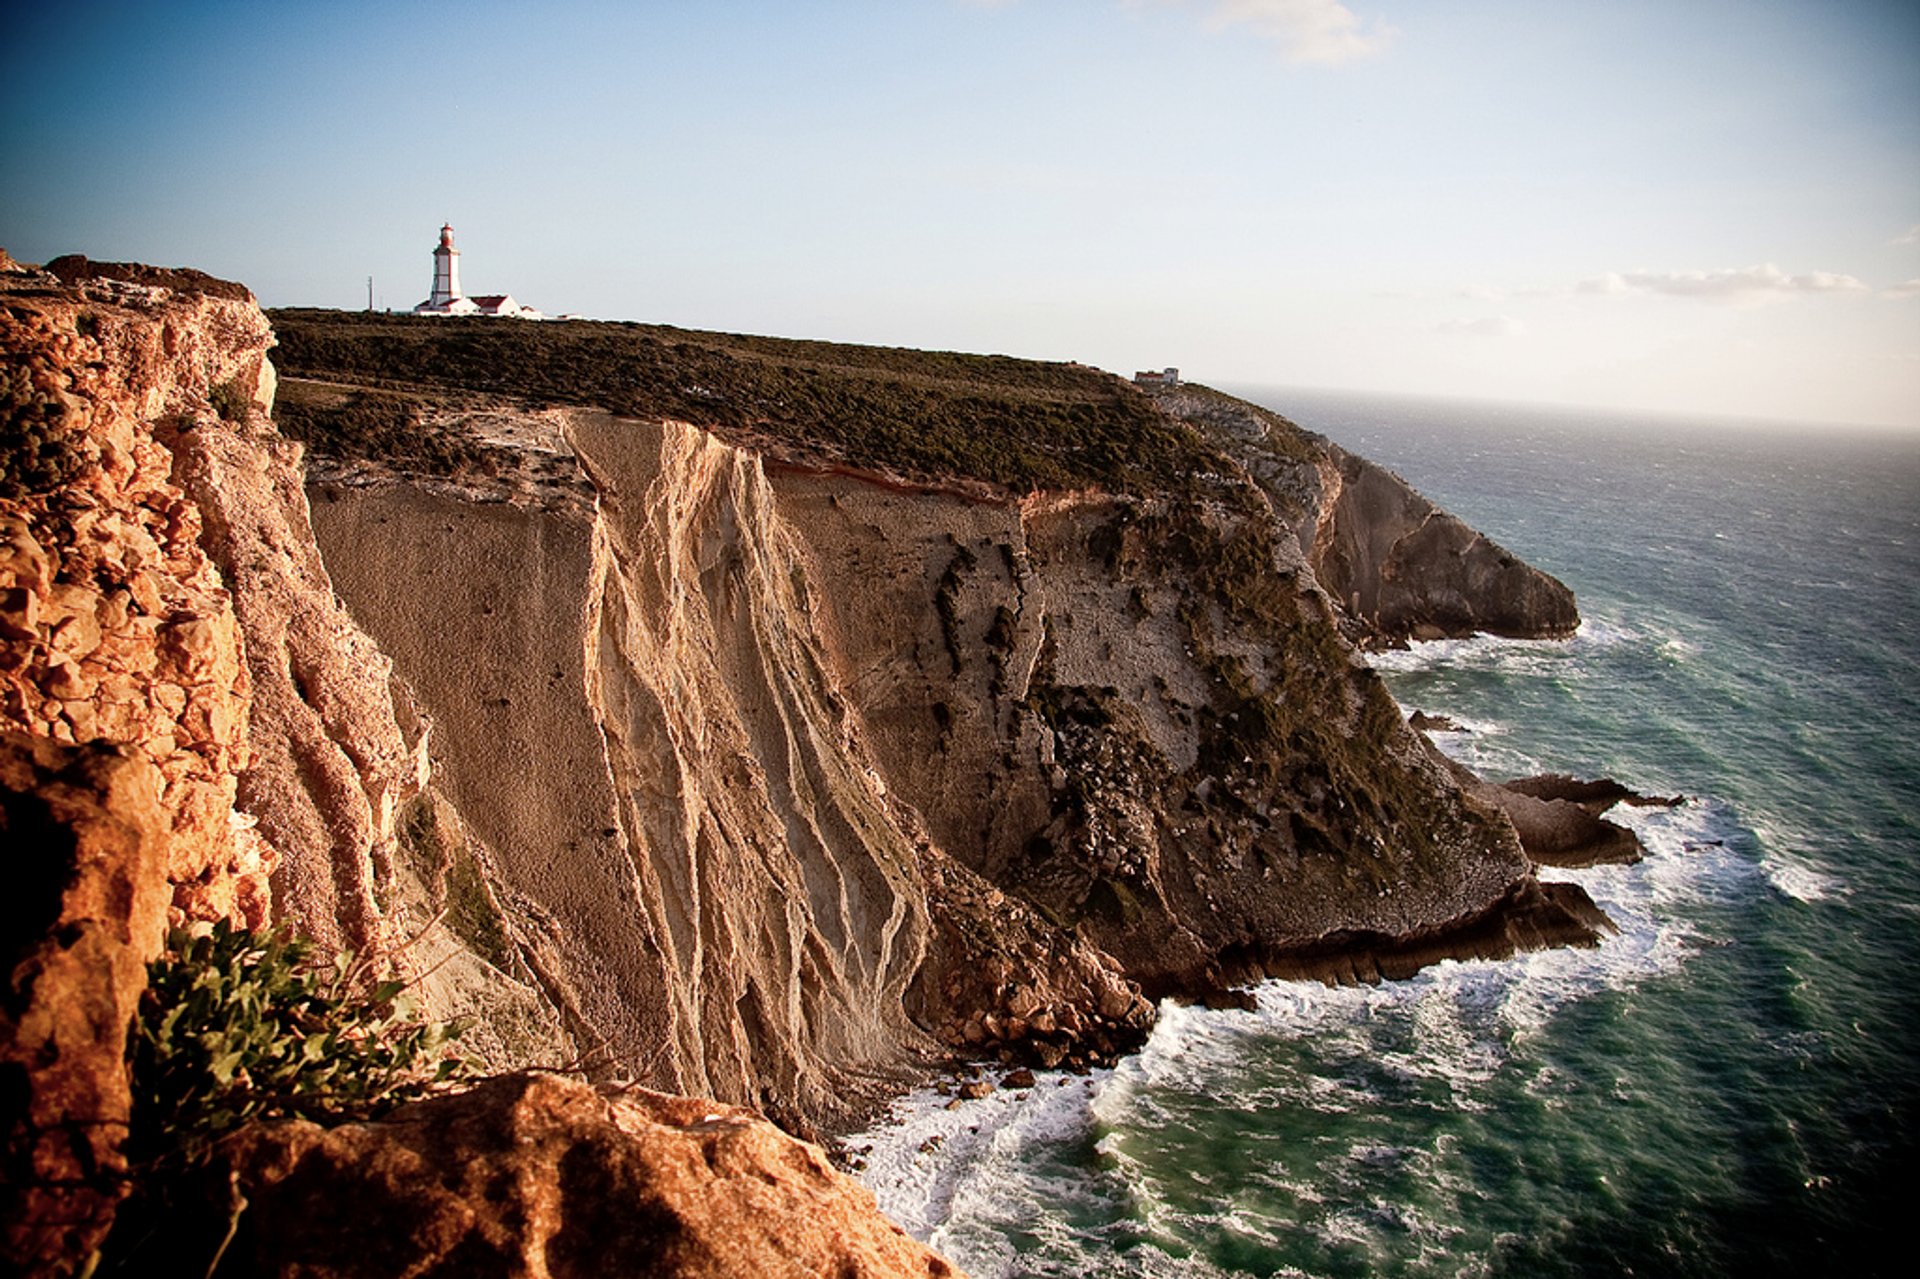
left=129, top=922, right=467, bottom=1162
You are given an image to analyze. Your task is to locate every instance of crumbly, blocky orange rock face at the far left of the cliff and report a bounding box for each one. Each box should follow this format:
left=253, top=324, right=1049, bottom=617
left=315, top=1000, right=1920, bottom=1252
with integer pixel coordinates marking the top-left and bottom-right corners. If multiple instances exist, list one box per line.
left=0, top=257, right=275, bottom=924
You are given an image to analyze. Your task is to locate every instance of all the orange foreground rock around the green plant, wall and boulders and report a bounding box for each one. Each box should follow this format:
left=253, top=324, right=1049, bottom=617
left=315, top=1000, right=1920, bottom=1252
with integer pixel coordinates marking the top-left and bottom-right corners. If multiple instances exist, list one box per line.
left=0, top=253, right=954, bottom=1275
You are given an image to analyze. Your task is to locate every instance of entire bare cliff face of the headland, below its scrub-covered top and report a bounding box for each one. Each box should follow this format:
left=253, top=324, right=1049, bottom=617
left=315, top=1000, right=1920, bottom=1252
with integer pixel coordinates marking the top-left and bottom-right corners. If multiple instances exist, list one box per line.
left=313, top=395, right=1599, bottom=1125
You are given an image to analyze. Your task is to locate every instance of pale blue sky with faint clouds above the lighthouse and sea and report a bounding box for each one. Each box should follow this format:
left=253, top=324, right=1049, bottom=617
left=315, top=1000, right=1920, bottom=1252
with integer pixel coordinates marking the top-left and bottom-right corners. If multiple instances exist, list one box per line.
left=0, top=0, right=1920, bottom=430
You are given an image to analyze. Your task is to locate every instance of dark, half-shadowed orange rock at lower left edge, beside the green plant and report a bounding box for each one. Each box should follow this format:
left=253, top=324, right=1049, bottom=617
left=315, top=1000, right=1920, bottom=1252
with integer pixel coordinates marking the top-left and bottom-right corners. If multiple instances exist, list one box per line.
left=0, top=734, right=173, bottom=1275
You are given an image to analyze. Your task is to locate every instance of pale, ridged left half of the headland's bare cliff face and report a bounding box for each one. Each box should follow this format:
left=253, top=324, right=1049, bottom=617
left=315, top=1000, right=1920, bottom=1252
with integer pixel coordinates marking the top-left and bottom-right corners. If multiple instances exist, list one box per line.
left=313, top=415, right=1146, bottom=1122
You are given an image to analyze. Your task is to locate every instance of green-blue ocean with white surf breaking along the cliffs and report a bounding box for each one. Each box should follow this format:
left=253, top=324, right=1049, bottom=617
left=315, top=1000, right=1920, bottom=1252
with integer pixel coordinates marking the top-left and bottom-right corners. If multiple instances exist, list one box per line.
left=854, top=388, right=1920, bottom=1279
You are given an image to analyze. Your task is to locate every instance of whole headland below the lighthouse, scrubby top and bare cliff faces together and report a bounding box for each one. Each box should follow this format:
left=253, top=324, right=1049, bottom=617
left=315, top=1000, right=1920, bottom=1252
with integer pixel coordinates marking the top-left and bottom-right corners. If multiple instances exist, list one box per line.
left=275, top=311, right=1599, bottom=1083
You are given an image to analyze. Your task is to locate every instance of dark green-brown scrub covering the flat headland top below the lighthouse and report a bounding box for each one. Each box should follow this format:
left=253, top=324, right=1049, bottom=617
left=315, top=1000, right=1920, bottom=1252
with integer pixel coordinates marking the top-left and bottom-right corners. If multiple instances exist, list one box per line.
left=269, top=309, right=1225, bottom=492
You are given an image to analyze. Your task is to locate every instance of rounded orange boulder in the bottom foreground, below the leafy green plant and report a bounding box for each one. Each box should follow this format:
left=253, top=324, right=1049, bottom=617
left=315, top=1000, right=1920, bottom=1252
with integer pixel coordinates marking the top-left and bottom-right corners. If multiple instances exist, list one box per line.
left=112, top=1075, right=960, bottom=1279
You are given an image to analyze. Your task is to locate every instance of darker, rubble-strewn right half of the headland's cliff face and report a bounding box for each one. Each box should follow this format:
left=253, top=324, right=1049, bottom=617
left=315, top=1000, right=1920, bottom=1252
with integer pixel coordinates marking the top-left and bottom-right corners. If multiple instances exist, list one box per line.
left=776, top=458, right=1580, bottom=995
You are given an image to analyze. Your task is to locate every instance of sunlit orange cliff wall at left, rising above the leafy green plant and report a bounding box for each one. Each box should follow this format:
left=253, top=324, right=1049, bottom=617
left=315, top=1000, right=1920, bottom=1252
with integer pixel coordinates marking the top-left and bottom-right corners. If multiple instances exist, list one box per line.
left=0, top=257, right=580, bottom=1064
